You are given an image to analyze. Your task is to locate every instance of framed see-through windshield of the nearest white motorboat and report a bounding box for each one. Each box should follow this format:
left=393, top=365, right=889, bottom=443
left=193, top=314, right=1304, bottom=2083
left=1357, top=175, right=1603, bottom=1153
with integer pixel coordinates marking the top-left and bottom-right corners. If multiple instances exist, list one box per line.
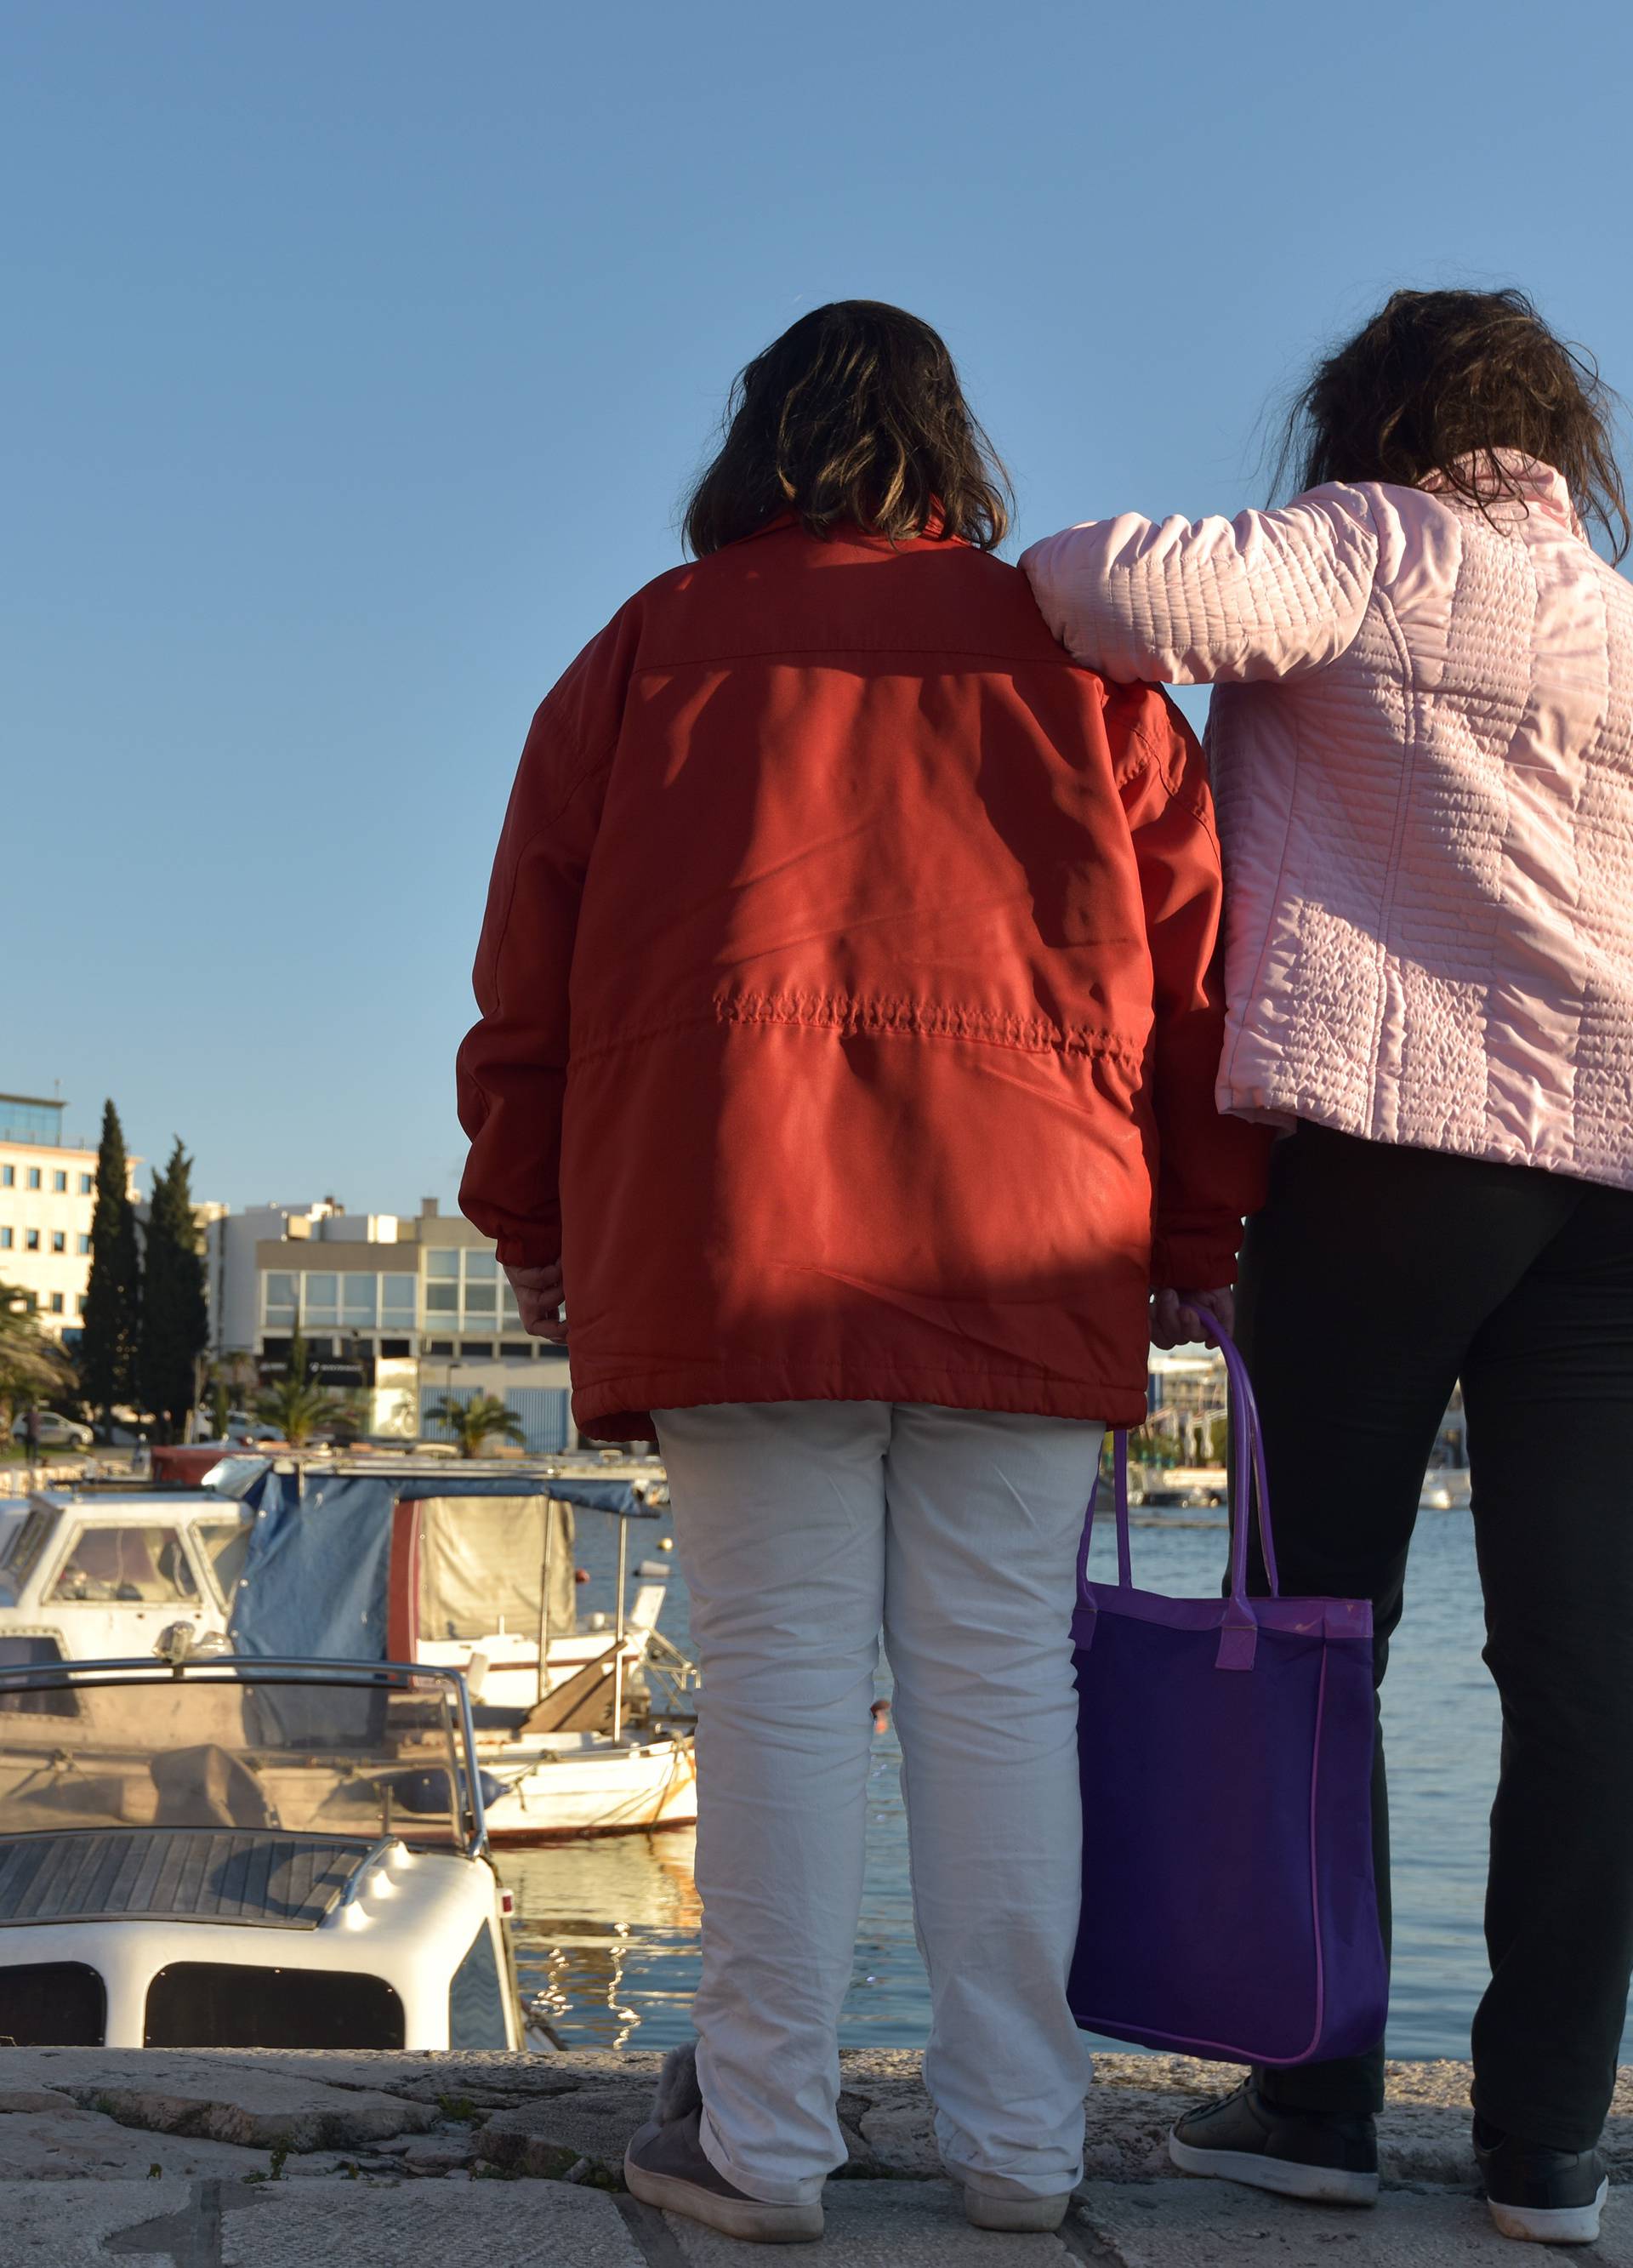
left=0, top=1661, right=481, bottom=1850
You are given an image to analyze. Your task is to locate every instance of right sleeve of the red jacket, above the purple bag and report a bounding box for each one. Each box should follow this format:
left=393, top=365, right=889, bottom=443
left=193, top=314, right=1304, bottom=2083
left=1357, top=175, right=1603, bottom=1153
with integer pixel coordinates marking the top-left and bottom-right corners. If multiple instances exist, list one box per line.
left=1124, top=687, right=1275, bottom=1291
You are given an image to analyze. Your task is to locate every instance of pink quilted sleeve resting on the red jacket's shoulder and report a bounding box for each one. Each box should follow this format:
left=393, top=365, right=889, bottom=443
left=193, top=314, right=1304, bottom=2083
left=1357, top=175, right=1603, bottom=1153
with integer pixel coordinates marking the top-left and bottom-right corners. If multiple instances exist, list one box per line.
left=1021, top=487, right=1379, bottom=685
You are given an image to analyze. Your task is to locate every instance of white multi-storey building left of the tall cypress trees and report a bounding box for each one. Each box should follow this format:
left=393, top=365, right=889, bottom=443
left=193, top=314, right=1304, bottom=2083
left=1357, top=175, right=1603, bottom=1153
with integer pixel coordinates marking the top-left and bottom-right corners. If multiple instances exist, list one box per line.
left=0, top=1096, right=136, bottom=1348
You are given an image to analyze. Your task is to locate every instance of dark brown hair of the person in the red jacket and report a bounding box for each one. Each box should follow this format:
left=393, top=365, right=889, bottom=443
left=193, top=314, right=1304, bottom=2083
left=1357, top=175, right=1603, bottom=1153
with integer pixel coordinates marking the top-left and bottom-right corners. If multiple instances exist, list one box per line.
left=685, top=299, right=1011, bottom=558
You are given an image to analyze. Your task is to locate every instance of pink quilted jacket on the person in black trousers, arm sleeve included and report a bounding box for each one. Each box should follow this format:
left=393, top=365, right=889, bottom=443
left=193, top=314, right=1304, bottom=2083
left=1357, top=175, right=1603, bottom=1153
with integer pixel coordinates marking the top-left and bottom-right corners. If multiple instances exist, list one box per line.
left=1021, top=456, right=1633, bottom=1188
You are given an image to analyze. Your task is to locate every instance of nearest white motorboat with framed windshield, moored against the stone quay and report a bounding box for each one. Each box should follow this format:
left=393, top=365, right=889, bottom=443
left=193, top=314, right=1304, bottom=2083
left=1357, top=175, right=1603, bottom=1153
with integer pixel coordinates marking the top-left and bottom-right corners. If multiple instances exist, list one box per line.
left=0, top=1658, right=524, bottom=2050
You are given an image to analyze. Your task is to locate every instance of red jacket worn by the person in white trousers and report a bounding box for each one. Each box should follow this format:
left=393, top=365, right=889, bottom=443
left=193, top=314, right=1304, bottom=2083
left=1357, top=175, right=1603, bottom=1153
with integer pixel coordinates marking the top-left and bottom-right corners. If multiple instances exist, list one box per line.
left=458, top=521, right=1263, bottom=1440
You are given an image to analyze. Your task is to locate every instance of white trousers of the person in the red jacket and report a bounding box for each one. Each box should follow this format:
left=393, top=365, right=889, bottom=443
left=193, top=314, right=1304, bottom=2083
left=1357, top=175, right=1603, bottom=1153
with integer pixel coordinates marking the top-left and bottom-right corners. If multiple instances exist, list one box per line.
left=656, top=1402, right=1102, bottom=2204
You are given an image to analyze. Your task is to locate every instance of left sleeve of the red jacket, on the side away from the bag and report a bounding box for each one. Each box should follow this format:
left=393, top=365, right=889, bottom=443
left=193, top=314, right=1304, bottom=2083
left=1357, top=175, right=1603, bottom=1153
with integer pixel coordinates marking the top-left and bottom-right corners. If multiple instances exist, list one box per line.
left=458, top=607, right=633, bottom=1268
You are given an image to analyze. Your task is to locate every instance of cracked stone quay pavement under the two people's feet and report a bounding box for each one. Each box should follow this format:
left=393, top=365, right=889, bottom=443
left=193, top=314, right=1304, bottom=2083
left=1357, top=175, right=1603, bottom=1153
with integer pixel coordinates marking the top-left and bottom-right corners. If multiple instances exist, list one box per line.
left=0, top=2048, right=1633, bottom=2268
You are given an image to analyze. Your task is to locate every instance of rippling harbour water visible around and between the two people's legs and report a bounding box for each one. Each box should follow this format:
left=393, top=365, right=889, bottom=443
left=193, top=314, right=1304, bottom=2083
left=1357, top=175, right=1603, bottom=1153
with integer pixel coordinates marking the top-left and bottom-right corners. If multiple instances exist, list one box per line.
left=499, top=1513, right=1633, bottom=2061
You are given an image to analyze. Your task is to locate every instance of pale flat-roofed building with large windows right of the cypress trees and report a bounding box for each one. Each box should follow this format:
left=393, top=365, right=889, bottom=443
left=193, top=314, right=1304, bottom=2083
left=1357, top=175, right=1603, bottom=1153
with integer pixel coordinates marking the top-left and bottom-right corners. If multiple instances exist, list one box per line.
left=204, top=1198, right=574, bottom=1450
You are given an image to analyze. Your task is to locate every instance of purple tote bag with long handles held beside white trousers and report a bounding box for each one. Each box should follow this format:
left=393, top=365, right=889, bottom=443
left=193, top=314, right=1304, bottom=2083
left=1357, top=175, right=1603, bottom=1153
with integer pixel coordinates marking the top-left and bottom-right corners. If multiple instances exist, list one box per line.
left=1071, top=1334, right=1388, bottom=2064
